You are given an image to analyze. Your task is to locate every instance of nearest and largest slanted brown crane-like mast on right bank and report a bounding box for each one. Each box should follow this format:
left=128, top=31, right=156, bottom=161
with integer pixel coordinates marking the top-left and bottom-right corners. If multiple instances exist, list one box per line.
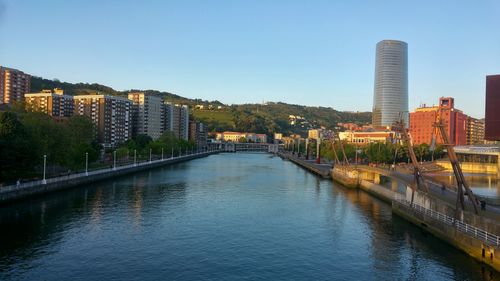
left=431, top=108, right=478, bottom=214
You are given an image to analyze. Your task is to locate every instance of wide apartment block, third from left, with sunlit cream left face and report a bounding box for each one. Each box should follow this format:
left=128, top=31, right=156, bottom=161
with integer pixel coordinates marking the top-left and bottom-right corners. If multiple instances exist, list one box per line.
left=74, top=94, right=132, bottom=147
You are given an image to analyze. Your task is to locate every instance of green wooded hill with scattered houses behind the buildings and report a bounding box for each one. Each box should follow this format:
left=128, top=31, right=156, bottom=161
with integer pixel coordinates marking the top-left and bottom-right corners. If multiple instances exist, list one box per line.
left=31, top=77, right=371, bottom=135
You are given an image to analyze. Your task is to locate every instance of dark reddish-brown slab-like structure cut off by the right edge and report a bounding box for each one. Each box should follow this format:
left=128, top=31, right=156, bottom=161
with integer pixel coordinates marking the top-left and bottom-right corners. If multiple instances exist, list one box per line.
left=484, top=75, right=500, bottom=141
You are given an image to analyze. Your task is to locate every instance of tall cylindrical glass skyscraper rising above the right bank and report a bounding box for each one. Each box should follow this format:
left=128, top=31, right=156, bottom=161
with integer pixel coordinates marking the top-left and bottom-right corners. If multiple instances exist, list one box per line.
left=372, top=40, right=408, bottom=128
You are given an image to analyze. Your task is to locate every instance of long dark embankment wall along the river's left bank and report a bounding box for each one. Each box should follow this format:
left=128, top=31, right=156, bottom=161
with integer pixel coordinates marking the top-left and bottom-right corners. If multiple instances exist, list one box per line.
left=0, top=152, right=218, bottom=205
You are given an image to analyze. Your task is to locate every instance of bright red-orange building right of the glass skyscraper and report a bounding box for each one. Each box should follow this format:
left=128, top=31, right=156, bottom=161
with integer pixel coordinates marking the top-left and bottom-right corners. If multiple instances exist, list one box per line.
left=410, top=97, right=467, bottom=145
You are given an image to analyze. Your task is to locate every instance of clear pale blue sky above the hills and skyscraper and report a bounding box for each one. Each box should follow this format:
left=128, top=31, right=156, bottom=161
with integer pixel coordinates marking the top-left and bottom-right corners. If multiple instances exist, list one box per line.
left=0, top=0, right=500, bottom=117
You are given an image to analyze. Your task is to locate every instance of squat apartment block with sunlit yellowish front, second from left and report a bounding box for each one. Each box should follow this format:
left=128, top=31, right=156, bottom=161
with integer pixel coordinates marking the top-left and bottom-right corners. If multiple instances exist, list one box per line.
left=24, top=88, right=74, bottom=117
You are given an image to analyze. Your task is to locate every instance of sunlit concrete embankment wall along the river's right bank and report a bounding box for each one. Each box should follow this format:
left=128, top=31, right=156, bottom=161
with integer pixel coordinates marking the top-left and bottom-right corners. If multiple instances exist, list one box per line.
left=280, top=155, right=500, bottom=272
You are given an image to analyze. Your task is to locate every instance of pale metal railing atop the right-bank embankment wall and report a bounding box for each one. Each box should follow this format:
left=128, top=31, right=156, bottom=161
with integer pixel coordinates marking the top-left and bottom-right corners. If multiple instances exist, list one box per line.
left=393, top=194, right=500, bottom=247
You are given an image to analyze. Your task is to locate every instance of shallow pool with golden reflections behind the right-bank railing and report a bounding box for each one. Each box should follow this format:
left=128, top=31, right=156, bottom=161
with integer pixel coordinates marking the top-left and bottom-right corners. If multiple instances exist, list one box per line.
left=430, top=172, right=500, bottom=198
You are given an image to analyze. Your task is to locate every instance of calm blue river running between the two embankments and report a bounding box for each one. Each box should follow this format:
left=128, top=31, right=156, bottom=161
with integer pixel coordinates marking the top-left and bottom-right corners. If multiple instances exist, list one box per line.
left=0, top=153, right=497, bottom=280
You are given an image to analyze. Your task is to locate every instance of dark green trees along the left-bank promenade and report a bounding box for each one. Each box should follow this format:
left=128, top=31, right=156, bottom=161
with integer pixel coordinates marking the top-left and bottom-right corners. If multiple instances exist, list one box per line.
left=0, top=108, right=196, bottom=185
